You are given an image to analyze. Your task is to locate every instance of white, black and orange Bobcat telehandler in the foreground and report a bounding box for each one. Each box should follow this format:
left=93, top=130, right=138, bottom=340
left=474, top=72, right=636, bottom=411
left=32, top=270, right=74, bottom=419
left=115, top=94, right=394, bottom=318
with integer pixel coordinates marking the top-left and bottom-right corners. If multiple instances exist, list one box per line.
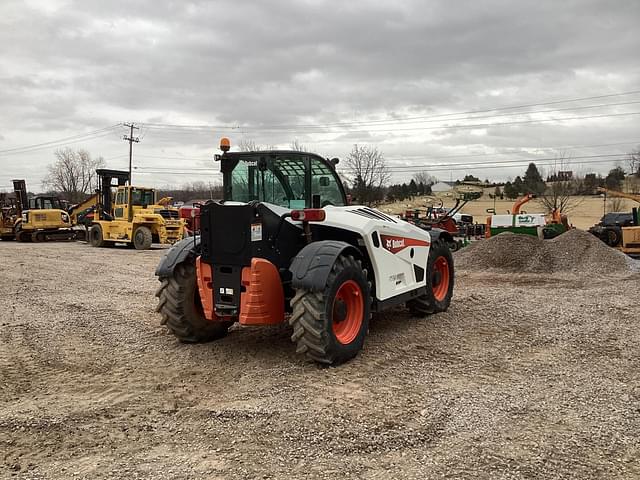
left=156, top=139, right=454, bottom=364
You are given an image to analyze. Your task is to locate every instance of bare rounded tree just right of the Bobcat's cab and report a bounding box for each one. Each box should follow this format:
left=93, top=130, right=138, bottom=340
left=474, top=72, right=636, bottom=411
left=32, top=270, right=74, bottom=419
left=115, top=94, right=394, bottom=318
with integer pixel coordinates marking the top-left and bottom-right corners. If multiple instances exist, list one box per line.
left=345, top=145, right=391, bottom=205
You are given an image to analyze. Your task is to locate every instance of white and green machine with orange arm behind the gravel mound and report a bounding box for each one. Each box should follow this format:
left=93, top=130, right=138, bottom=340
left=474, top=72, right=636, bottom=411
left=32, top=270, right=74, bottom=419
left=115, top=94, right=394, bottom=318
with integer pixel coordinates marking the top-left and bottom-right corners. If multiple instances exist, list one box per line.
left=485, top=193, right=571, bottom=239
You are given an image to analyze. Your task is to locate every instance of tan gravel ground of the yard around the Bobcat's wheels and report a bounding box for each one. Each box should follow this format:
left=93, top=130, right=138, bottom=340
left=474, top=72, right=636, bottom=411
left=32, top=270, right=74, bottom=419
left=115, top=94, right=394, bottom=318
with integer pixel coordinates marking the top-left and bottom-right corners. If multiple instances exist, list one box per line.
left=0, top=238, right=640, bottom=479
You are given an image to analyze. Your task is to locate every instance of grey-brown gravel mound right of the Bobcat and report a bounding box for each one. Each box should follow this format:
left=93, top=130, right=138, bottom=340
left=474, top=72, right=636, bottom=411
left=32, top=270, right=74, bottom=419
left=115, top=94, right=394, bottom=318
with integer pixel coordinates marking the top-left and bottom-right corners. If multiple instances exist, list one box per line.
left=455, top=230, right=633, bottom=274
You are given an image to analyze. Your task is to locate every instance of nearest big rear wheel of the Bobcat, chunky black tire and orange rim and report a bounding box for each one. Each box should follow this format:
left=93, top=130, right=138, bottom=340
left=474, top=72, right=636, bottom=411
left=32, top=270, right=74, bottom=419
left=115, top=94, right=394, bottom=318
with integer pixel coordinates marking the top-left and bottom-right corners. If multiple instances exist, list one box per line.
left=289, top=255, right=371, bottom=365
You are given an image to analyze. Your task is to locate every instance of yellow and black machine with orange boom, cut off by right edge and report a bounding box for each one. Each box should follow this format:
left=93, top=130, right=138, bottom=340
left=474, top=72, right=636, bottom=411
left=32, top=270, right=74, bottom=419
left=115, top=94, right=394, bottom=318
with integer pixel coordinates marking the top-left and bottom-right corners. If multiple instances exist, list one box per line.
left=589, top=187, right=640, bottom=255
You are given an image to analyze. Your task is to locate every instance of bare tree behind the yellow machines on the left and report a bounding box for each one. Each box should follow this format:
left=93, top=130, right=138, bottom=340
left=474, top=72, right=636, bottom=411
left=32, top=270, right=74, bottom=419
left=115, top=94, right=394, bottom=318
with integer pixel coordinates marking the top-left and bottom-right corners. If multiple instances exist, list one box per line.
left=42, top=147, right=104, bottom=203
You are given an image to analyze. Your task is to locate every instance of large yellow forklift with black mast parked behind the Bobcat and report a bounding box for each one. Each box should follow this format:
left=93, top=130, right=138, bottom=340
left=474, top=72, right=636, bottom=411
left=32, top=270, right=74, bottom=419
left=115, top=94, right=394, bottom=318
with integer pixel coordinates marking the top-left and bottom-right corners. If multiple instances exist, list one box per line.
left=88, top=169, right=186, bottom=250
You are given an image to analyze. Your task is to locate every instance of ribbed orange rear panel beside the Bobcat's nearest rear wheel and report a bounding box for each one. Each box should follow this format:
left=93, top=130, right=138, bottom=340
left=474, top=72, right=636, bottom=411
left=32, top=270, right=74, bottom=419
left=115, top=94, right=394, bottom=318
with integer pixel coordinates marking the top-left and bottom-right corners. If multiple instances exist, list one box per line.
left=240, top=258, right=284, bottom=325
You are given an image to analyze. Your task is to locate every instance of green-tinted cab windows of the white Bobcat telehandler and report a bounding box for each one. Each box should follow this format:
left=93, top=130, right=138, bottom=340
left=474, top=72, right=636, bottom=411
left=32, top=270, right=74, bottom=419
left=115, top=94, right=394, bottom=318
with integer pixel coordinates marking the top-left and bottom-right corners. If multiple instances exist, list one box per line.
left=225, top=153, right=345, bottom=209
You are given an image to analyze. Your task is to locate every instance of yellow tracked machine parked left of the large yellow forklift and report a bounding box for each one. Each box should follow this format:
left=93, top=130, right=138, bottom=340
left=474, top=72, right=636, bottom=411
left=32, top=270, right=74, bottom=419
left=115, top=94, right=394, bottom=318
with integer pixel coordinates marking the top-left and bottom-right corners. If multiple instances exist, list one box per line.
left=12, top=180, right=75, bottom=242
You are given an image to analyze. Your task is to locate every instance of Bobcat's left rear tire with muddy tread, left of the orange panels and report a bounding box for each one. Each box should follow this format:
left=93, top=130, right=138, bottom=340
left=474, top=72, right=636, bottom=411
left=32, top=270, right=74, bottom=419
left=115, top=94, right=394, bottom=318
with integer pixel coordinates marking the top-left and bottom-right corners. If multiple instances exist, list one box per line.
left=156, top=260, right=233, bottom=343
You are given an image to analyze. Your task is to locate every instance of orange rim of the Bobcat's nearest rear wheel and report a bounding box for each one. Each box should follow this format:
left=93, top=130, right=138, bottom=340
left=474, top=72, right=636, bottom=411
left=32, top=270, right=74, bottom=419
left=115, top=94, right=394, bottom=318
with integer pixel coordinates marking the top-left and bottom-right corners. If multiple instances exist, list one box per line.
left=331, top=280, right=364, bottom=345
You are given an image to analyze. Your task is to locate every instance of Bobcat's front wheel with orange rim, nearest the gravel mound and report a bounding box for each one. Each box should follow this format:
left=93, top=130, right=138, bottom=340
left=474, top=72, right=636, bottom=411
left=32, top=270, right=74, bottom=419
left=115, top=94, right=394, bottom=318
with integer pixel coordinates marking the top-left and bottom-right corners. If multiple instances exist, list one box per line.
left=407, top=240, right=454, bottom=317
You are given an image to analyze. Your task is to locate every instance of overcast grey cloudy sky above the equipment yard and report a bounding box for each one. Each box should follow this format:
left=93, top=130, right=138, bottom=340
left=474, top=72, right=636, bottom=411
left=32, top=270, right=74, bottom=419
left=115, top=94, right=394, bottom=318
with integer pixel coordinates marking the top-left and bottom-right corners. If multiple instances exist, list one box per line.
left=0, top=0, right=640, bottom=190
